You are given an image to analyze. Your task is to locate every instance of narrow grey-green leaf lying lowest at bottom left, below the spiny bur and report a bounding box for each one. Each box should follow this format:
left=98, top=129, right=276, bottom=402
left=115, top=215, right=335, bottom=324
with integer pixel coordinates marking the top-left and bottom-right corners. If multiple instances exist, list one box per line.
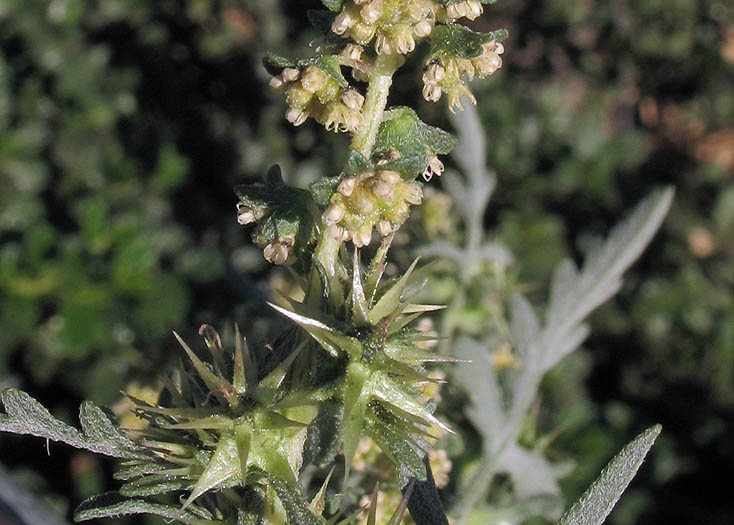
left=74, top=492, right=218, bottom=525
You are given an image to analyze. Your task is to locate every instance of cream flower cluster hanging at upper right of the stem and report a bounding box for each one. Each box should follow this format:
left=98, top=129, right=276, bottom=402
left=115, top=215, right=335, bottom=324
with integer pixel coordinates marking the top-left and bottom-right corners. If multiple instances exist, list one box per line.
left=423, top=37, right=505, bottom=113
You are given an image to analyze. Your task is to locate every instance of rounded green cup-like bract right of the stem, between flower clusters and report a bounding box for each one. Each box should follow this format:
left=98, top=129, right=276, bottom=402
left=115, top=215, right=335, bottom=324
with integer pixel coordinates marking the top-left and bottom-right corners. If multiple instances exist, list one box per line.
left=373, top=107, right=456, bottom=180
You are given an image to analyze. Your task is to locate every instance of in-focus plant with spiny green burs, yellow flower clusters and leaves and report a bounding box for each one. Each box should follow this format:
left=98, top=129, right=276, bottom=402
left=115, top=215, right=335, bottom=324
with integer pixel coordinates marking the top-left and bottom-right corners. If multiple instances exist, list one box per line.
left=0, top=0, right=672, bottom=525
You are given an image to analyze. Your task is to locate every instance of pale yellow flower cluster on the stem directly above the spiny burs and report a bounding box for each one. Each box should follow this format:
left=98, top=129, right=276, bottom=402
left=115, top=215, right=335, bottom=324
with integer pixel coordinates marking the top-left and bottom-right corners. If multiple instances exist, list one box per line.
left=322, top=170, right=423, bottom=247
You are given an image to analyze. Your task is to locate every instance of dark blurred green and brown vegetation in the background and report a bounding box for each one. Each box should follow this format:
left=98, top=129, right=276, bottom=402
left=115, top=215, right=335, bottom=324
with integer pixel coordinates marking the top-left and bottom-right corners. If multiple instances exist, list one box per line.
left=0, top=0, right=734, bottom=523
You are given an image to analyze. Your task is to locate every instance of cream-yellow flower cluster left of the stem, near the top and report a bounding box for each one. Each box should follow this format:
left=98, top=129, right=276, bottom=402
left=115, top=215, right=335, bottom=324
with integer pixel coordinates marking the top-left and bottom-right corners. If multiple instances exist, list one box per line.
left=270, top=64, right=364, bottom=133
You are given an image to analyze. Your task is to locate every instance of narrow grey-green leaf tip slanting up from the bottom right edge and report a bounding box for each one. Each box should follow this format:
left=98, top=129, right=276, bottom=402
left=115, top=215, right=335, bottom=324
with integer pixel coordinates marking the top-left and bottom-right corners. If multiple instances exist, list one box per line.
left=558, top=425, right=662, bottom=525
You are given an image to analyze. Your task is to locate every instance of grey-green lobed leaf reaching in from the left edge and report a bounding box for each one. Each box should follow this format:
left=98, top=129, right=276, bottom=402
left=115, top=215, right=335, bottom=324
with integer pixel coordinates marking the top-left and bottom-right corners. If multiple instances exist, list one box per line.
left=0, top=388, right=150, bottom=459
